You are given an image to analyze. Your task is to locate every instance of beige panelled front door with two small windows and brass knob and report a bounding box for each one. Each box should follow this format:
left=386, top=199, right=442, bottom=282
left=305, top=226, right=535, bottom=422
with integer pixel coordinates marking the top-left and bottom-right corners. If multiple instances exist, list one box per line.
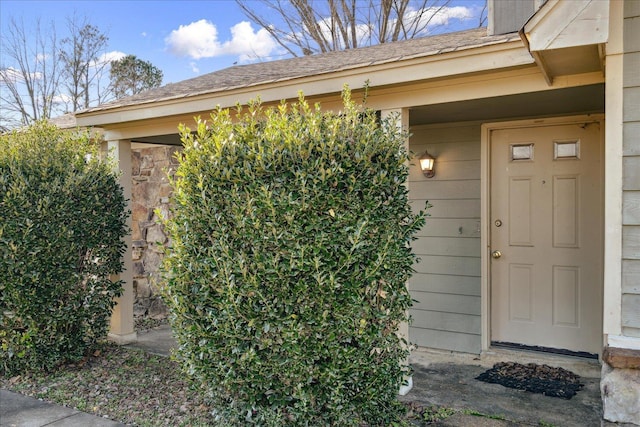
left=489, top=122, right=603, bottom=354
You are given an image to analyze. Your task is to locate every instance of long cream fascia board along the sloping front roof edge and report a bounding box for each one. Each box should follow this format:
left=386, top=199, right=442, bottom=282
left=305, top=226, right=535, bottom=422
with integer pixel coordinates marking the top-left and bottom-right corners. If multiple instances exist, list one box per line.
left=77, top=40, right=534, bottom=126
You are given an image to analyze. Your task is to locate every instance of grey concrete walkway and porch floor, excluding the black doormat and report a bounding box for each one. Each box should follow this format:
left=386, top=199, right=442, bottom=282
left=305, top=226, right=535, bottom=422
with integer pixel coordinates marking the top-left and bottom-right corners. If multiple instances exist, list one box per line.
left=0, top=326, right=616, bottom=427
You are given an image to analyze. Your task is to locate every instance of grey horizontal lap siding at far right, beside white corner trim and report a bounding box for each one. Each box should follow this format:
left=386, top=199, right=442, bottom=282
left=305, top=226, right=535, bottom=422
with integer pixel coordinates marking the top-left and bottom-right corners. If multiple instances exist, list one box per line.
left=622, top=6, right=640, bottom=337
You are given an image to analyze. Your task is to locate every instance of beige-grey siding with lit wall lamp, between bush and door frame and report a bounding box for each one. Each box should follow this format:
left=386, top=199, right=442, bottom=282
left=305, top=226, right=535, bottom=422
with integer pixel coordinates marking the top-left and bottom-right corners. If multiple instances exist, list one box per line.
left=409, top=124, right=481, bottom=353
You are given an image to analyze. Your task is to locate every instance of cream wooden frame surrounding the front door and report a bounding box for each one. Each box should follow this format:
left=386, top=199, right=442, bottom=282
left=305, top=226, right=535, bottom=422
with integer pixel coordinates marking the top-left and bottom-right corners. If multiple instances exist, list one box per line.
left=480, top=114, right=606, bottom=353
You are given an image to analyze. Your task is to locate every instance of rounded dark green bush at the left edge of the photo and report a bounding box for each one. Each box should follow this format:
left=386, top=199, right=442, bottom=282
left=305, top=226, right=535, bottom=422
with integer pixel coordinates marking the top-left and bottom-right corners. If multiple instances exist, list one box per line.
left=0, top=122, right=127, bottom=373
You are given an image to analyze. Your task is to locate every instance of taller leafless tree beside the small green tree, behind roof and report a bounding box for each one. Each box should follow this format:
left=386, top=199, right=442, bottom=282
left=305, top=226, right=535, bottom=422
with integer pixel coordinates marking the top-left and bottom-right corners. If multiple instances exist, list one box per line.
left=60, top=15, right=109, bottom=111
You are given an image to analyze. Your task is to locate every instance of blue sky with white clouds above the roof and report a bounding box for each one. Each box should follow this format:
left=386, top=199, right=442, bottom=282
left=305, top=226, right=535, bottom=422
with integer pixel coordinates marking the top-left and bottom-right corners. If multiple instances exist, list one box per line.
left=0, top=0, right=484, bottom=84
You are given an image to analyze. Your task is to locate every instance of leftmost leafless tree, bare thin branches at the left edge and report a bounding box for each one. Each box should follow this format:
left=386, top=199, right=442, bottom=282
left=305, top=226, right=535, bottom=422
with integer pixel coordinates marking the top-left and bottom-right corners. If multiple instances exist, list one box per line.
left=0, top=19, right=60, bottom=128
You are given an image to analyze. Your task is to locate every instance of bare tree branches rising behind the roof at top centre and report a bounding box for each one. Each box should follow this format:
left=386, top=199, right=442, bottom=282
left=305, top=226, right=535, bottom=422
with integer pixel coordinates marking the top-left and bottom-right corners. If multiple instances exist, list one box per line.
left=236, top=0, right=450, bottom=56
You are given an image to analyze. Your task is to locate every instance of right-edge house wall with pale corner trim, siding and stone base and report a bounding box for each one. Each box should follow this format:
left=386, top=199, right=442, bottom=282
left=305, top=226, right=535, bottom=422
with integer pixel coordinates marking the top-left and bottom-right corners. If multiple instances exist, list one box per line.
left=600, top=1, right=640, bottom=425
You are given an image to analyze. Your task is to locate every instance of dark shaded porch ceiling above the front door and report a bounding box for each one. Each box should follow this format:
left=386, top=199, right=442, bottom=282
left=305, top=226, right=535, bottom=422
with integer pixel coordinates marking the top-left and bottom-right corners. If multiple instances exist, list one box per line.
left=409, top=84, right=604, bottom=126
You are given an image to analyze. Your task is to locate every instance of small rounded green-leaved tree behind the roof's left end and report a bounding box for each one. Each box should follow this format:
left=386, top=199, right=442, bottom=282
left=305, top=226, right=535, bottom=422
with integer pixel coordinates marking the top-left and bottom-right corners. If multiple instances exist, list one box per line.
left=109, top=55, right=162, bottom=98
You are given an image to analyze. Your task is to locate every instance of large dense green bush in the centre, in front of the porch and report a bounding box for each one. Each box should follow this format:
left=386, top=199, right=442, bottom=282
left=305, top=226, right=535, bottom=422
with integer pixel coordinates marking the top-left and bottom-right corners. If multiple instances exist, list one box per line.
left=163, top=89, right=423, bottom=426
